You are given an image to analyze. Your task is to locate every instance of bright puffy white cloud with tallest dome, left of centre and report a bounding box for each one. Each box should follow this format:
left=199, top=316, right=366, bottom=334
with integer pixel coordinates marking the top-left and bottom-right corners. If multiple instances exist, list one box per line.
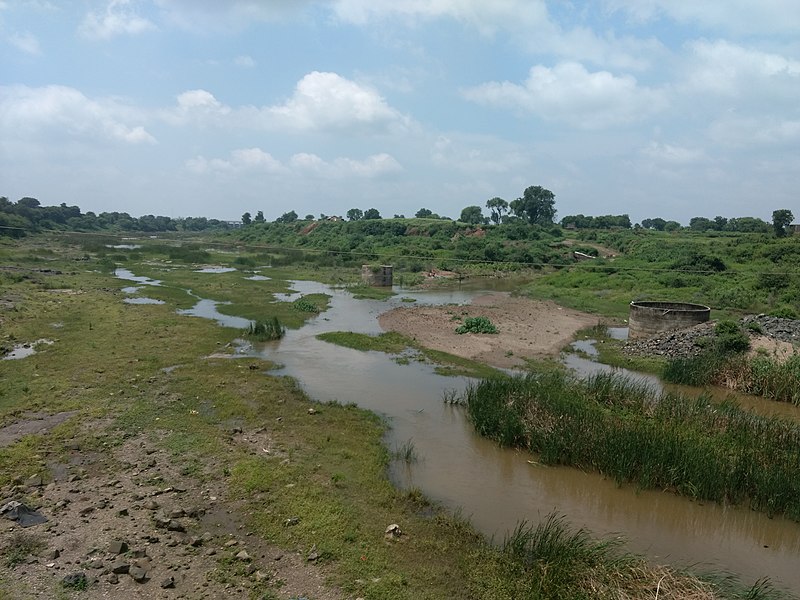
left=162, top=71, right=410, bottom=131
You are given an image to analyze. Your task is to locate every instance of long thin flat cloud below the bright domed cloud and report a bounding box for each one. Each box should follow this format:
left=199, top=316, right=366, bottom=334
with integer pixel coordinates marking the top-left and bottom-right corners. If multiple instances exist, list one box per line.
left=186, top=148, right=402, bottom=179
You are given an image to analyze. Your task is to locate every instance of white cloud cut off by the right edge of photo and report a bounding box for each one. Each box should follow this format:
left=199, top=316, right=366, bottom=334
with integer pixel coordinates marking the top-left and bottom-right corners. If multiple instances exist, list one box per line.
left=688, top=40, right=800, bottom=99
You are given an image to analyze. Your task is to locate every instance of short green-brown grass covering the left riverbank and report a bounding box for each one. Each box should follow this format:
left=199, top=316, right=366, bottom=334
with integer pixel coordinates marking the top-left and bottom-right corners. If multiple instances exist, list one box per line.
left=0, top=238, right=788, bottom=600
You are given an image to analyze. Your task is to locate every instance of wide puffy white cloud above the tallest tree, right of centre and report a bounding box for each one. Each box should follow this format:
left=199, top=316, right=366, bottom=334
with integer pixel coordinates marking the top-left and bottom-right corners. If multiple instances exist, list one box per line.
left=463, top=62, right=667, bottom=129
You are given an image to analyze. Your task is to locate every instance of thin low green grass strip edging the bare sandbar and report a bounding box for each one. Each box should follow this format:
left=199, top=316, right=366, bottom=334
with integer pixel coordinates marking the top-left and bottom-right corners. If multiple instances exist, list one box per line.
left=317, top=331, right=500, bottom=378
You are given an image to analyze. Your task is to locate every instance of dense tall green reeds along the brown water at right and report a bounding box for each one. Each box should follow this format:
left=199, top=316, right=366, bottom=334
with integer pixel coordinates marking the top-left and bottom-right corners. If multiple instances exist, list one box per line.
left=464, top=373, right=800, bottom=520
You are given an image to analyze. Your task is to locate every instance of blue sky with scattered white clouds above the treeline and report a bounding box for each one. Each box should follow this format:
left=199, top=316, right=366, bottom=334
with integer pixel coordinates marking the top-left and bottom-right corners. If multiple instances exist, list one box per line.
left=0, top=0, right=800, bottom=224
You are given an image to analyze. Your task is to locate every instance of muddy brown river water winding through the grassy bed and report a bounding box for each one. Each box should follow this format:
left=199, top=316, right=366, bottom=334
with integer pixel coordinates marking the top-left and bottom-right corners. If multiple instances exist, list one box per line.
left=117, top=270, right=800, bottom=594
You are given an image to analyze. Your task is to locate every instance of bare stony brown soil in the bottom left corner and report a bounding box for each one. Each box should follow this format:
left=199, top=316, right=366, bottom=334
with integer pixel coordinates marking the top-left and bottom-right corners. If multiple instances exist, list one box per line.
left=0, top=424, right=345, bottom=600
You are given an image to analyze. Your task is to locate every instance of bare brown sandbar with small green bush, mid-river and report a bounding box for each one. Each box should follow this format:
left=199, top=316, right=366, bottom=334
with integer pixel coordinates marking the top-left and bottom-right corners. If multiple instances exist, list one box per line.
left=379, top=292, right=598, bottom=368
